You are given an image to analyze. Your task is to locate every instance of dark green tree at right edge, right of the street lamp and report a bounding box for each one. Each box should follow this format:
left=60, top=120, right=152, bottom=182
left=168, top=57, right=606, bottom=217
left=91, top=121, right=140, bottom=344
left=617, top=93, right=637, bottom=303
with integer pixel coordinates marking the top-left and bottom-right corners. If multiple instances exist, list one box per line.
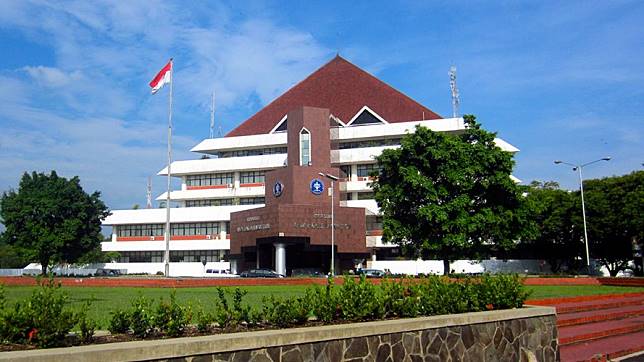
left=584, top=171, right=644, bottom=276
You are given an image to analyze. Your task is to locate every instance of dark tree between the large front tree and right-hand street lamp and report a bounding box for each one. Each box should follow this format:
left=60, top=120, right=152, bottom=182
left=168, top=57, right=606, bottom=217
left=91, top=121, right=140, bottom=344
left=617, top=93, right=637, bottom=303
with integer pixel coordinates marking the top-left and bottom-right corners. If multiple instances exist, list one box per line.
left=524, top=181, right=584, bottom=273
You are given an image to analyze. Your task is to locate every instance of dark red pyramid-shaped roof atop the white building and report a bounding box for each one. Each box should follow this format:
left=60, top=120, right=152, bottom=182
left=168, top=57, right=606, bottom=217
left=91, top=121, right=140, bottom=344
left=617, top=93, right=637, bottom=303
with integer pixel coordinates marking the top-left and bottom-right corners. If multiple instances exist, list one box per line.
left=226, top=55, right=442, bottom=137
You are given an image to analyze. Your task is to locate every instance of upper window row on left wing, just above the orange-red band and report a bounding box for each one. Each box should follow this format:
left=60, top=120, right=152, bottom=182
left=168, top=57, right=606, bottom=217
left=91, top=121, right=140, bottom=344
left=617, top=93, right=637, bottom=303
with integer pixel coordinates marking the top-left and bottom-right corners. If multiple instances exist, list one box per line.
left=116, top=221, right=230, bottom=237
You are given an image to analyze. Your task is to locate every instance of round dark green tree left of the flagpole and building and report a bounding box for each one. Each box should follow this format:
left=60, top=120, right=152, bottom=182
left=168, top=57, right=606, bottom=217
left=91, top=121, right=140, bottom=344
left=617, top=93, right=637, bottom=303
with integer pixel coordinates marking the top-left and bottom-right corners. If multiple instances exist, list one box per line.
left=0, top=171, right=109, bottom=274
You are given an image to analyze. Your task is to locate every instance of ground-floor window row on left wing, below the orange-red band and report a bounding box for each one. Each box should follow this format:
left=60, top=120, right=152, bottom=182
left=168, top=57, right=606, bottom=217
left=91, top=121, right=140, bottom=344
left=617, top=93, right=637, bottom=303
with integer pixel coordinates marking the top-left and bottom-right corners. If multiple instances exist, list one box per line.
left=117, top=250, right=228, bottom=263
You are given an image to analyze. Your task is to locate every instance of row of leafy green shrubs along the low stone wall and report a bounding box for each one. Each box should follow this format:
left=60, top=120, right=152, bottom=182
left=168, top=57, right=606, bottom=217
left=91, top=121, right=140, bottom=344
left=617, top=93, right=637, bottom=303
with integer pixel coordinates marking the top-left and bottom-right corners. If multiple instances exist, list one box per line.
left=0, top=275, right=528, bottom=347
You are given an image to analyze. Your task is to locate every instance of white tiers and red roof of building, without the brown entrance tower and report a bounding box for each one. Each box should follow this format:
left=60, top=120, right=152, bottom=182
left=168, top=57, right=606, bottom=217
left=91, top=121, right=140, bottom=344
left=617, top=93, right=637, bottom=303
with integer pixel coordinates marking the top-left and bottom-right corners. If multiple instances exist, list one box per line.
left=102, top=57, right=518, bottom=276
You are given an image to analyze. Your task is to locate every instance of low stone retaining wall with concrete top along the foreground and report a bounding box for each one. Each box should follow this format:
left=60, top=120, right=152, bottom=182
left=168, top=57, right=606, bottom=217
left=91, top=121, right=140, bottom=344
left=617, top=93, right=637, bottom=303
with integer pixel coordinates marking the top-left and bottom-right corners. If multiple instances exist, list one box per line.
left=0, top=307, right=559, bottom=362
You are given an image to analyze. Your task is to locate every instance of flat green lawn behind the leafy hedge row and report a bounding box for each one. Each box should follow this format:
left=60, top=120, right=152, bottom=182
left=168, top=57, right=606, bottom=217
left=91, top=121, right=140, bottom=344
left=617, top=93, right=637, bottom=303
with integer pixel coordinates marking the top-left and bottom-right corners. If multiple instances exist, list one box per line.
left=5, top=285, right=644, bottom=329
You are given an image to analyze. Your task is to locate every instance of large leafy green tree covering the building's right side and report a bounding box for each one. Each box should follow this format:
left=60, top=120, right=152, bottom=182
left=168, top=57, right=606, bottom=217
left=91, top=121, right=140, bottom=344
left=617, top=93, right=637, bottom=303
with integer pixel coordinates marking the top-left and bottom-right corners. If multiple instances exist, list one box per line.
left=372, top=116, right=533, bottom=274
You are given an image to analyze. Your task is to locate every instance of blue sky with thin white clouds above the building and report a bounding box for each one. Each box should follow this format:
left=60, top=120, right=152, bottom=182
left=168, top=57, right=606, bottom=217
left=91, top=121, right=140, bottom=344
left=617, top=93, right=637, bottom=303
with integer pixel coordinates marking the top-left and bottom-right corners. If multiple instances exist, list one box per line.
left=0, top=0, right=644, bottom=209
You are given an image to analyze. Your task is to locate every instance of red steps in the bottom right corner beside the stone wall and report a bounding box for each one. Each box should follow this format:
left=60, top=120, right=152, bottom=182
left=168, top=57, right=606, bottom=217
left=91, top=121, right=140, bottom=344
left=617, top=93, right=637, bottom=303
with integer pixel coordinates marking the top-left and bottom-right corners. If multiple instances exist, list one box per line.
left=530, top=293, right=644, bottom=362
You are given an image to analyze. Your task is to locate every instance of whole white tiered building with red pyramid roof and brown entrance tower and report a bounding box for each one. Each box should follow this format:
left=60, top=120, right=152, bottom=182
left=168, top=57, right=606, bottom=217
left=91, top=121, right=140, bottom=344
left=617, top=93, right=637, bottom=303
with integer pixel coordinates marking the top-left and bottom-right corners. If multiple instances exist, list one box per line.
left=102, top=56, right=518, bottom=276
